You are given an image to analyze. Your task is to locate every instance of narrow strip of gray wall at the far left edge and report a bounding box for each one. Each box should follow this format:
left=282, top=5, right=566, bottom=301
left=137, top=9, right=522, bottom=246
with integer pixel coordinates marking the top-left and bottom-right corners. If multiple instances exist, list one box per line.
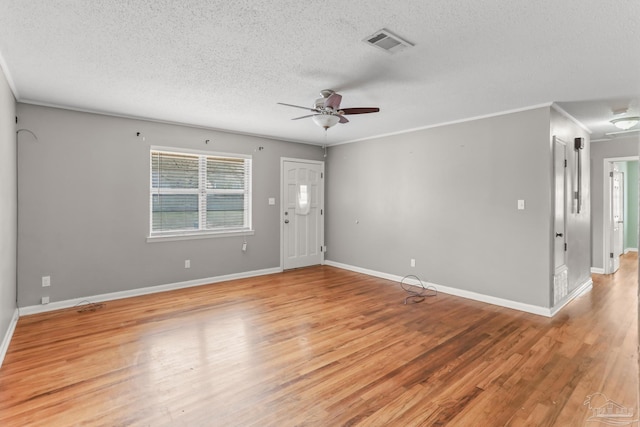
left=0, top=69, right=18, bottom=341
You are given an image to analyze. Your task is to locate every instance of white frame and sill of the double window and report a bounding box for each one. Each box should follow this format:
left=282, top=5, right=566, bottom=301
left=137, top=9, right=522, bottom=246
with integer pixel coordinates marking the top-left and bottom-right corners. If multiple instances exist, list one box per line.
left=147, top=146, right=254, bottom=242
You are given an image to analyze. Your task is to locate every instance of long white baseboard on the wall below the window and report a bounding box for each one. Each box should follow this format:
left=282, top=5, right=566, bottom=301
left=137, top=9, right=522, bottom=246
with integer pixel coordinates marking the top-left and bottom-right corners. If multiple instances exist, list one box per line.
left=20, top=267, right=282, bottom=316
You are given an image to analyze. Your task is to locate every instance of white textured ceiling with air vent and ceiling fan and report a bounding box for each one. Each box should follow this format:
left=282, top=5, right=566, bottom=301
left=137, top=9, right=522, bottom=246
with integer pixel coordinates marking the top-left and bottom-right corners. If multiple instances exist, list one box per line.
left=0, top=0, right=640, bottom=145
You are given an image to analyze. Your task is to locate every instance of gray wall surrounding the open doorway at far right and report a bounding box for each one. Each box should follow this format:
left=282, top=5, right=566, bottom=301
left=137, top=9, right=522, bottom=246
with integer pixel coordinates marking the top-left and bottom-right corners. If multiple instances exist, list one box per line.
left=591, top=138, right=640, bottom=269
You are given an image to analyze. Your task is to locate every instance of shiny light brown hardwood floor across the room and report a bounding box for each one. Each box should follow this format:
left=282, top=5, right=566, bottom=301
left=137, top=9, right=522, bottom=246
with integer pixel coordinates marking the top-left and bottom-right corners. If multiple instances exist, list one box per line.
left=0, top=253, right=638, bottom=427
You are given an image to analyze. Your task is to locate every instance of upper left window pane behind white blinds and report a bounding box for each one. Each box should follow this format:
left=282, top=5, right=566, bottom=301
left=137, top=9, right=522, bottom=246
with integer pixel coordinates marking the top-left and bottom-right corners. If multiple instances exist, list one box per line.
left=151, top=152, right=198, bottom=189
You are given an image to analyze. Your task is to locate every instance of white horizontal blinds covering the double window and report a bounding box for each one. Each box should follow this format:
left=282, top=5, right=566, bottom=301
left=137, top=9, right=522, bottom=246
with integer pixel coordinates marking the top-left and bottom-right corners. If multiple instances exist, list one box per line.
left=150, top=150, right=251, bottom=236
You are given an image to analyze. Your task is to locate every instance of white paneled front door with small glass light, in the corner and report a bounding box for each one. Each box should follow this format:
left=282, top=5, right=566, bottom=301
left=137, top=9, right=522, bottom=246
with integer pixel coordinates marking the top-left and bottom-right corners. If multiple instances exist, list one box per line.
left=282, top=160, right=324, bottom=270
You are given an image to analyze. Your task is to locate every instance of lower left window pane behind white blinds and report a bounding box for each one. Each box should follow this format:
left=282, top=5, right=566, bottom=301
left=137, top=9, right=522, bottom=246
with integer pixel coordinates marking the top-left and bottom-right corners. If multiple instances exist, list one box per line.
left=151, top=194, right=199, bottom=231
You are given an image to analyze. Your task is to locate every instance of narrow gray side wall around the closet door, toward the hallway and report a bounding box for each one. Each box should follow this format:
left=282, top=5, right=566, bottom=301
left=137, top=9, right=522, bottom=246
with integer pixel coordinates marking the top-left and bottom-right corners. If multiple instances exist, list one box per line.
left=551, top=109, right=591, bottom=297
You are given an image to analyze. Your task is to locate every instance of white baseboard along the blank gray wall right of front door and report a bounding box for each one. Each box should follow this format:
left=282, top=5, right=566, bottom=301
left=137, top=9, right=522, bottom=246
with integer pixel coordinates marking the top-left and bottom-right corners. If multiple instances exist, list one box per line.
left=325, top=261, right=555, bottom=317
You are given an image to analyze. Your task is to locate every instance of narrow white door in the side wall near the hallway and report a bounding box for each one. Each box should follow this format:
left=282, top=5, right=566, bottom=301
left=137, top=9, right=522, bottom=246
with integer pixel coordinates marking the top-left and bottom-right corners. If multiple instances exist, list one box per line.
left=553, top=137, right=568, bottom=305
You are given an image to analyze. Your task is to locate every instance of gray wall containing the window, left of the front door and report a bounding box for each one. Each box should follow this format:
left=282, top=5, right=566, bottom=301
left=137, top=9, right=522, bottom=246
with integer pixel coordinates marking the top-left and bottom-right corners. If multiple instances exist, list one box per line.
left=17, top=103, right=323, bottom=307
